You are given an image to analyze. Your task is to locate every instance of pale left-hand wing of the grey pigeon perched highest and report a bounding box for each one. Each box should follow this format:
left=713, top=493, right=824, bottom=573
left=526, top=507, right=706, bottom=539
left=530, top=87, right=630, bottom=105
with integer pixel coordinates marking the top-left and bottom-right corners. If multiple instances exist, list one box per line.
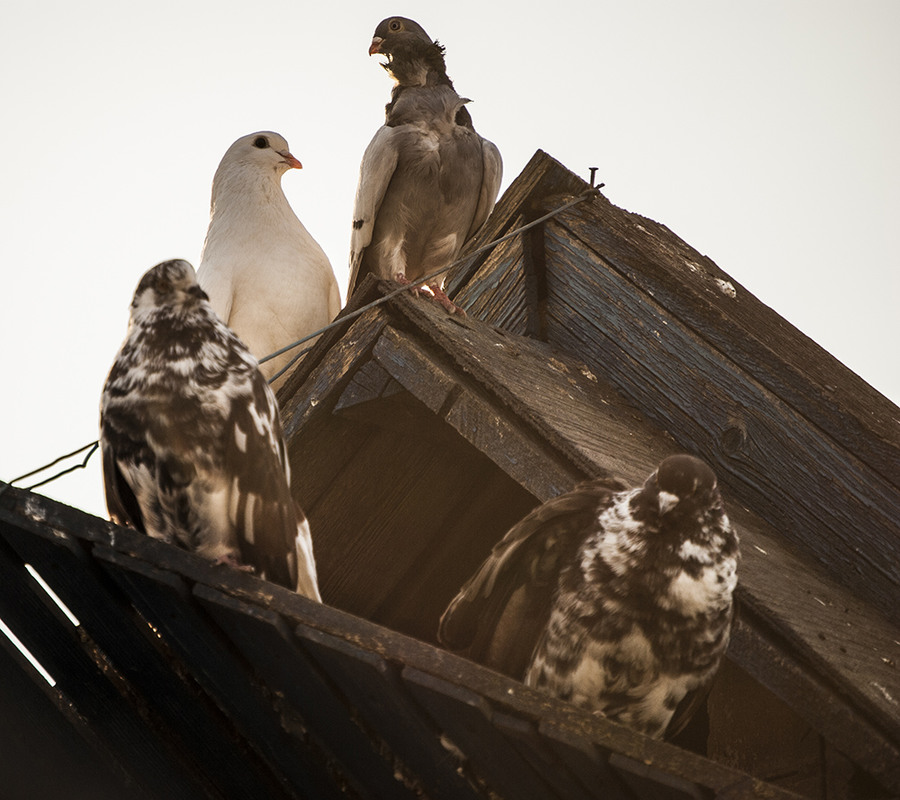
left=347, top=125, right=401, bottom=297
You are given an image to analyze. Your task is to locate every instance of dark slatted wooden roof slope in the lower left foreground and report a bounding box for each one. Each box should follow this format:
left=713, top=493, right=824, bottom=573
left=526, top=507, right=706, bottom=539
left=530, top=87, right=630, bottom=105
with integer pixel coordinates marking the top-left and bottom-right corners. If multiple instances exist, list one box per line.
left=0, top=486, right=796, bottom=800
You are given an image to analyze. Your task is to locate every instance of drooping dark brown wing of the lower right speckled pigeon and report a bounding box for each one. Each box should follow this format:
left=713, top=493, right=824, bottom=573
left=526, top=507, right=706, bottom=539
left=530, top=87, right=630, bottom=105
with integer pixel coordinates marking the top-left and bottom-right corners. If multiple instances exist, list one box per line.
left=438, top=479, right=625, bottom=679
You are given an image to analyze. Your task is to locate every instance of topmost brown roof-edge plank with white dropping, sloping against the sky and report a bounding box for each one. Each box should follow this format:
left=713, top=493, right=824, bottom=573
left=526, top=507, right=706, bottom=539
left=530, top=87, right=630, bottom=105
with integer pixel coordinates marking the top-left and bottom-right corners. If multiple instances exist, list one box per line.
left=557, top=198, right=900, bottom=487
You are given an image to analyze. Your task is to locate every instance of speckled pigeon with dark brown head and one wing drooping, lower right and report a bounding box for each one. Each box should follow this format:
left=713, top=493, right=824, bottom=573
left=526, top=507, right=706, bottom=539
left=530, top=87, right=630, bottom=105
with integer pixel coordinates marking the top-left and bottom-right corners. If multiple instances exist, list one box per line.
left=439, top=455, right=738, bottom=737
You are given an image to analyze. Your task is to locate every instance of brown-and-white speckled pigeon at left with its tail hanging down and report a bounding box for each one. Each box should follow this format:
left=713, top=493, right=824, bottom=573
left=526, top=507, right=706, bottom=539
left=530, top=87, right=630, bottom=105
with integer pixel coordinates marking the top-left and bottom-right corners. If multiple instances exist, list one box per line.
left=100, top=260, right=321, bottom=600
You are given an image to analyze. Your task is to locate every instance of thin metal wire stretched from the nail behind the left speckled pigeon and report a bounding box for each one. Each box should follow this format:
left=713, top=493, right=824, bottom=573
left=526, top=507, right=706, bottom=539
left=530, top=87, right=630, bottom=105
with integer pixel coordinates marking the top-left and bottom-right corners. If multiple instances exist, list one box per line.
left=0, top=184, right=604, bottom=494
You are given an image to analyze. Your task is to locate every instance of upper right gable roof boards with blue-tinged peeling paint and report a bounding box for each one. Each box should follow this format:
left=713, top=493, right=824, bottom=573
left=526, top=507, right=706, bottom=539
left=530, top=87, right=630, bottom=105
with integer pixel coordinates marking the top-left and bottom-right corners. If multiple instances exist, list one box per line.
left=452, top=152, right=900, bottom=622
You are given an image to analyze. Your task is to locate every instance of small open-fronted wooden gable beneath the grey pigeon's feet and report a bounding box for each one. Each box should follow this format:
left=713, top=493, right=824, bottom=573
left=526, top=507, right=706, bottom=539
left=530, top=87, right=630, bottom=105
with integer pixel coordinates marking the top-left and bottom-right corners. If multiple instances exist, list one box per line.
left=280, top=276, right=900, bottom=787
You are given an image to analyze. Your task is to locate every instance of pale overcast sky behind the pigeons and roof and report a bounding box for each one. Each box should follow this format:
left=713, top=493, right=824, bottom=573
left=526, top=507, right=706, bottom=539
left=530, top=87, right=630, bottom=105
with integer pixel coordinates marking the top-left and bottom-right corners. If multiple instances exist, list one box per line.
left=0, top=0, right=900, bottom=514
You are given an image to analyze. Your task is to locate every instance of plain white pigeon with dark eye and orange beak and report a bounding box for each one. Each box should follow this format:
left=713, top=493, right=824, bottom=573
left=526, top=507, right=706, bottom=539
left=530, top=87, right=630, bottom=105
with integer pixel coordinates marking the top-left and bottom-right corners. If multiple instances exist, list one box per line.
left=197, top=131, right=341, bottom=388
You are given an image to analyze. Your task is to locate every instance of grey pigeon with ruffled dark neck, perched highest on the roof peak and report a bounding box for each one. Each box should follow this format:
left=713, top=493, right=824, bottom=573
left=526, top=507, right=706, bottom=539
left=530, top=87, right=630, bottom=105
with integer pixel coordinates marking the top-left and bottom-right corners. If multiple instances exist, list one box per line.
left=348, top=17, right=503, bottom=310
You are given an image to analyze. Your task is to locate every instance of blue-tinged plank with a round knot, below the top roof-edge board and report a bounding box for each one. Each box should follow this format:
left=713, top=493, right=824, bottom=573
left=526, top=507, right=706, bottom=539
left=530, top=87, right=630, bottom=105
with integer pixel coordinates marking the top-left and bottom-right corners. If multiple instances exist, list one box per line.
left=548, top=220, right=900, bottom=619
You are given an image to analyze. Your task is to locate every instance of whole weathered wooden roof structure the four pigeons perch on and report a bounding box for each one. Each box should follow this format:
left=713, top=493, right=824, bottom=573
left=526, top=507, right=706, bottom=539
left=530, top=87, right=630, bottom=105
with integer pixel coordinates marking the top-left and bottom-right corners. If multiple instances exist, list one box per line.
left=0, top=153, right=900, bottom=800
